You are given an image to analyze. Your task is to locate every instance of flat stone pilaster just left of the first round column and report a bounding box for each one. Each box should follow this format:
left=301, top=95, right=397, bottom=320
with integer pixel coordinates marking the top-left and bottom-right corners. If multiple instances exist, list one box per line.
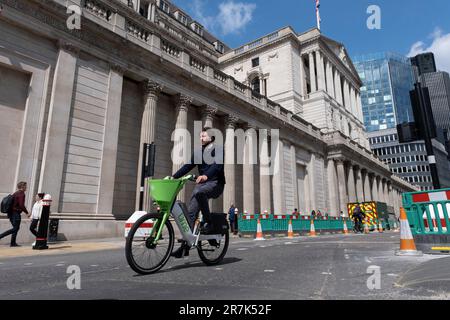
left=97, top=65, right=124, bottom=215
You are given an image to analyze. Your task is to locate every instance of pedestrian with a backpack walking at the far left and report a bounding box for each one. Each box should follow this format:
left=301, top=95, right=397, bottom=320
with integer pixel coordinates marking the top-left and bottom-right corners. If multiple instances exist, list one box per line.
left=0, top=181, right=31, bottom=247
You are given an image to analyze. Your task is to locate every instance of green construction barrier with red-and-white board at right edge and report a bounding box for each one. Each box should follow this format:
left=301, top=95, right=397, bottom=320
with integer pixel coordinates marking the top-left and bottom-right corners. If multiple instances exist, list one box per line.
left=402, top=189, right=450, bottom=253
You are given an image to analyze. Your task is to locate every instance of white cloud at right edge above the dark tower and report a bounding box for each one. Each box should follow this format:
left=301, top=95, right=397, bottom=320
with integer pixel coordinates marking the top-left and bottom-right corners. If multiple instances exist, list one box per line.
left=408, top=28, right=450, bottom=72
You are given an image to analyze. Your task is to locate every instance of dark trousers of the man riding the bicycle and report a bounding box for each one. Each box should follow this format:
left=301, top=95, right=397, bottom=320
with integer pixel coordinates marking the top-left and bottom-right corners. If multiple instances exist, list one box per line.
left=188, top=181, right=225, bottom=222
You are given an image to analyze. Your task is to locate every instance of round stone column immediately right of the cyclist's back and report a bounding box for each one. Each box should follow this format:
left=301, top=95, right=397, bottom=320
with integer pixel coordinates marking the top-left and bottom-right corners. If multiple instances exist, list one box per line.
left=223, top=115, right=239, bottom=212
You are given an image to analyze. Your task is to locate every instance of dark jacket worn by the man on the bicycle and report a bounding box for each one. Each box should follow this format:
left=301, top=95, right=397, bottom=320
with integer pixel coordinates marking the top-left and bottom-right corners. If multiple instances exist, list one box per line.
left=173, top=142, right=225, bottom=184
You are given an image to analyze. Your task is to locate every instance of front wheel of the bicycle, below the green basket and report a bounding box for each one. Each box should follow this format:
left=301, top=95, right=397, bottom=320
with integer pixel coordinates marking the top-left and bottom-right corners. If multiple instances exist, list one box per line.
left=125, top=213, right=175, bottom=274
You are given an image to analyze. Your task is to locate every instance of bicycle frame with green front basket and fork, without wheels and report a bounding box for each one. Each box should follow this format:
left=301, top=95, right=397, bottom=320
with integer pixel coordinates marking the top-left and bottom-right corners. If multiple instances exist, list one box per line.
left=150, top=175, right=222, bottom=247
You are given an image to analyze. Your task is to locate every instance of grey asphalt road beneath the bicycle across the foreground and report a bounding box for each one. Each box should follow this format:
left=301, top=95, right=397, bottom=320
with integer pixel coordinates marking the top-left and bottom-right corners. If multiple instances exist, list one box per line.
left=0, top=233, right=450, bottom=300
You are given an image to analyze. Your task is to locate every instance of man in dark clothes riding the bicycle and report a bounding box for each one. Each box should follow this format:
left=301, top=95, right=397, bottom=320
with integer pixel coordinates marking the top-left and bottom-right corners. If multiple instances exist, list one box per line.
left=172, top=128, right=225, bottom=258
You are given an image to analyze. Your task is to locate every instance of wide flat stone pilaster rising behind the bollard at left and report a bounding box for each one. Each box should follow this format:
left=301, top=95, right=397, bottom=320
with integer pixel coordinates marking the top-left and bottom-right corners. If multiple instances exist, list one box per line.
left=38, top=42, right=79, bottom=212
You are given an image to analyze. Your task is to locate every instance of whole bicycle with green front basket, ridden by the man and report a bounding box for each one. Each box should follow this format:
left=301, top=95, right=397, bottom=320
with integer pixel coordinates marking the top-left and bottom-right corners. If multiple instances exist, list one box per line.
left=125, top=175, right=229, bottom=275
